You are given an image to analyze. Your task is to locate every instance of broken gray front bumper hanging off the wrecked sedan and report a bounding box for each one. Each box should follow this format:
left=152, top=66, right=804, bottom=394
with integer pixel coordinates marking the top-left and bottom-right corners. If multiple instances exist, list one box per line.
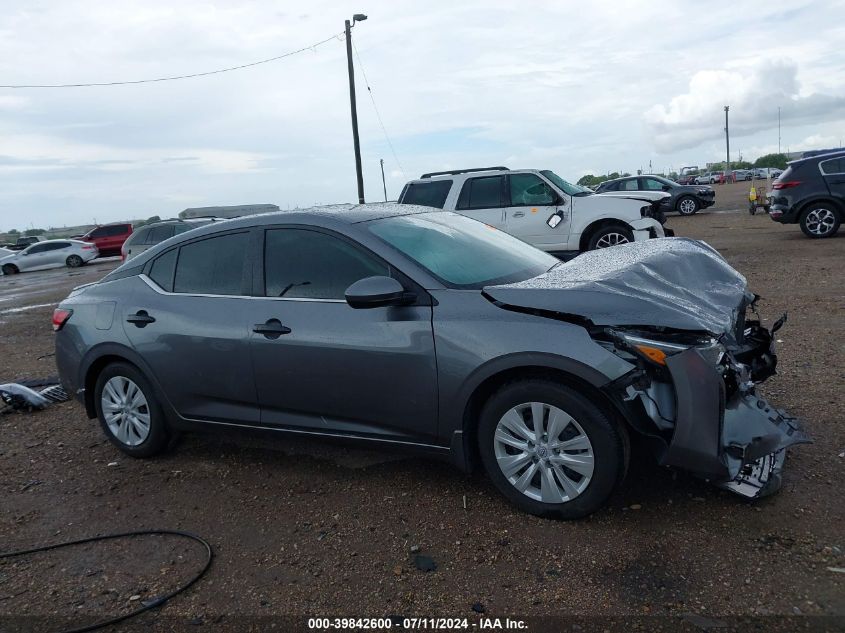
left=661, top=348, right=812, bottom=498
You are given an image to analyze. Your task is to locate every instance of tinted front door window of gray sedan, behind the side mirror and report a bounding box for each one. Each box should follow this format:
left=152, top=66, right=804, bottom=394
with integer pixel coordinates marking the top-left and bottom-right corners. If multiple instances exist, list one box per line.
left=264, top=229, right=390, bottom=299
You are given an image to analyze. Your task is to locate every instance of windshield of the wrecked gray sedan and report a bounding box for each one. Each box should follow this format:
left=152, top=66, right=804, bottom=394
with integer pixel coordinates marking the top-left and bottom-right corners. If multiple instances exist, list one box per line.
left=368, top=212, right=560, bottom=290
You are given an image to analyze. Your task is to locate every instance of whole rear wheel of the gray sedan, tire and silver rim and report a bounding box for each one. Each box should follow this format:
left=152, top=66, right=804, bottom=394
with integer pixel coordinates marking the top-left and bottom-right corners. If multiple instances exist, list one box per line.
left=94, top=363, right=170, bottom=457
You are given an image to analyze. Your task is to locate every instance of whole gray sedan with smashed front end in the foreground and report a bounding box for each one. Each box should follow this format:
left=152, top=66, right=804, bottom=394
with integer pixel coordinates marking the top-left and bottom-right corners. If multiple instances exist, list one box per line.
left=53, top=203, right=808, bottom=518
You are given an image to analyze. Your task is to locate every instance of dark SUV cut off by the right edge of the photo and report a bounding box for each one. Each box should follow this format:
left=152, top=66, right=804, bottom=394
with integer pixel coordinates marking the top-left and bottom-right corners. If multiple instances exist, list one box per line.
left=769, top=152, right=845, bottom=238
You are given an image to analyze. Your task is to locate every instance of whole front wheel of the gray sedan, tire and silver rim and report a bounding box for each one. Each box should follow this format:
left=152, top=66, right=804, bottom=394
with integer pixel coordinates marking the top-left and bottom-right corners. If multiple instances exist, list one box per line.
left=478, top=378, right=625, bottom=519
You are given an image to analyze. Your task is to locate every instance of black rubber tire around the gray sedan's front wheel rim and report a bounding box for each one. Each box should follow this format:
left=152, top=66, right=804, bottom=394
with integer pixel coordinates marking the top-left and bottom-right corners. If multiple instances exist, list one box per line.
left=478, top=377, right=627, bottom=519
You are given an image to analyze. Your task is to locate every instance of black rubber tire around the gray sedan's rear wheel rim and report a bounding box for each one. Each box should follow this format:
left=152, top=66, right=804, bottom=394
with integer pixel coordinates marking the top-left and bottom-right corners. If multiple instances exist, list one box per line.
left=94, top=363, right=171, bottom=457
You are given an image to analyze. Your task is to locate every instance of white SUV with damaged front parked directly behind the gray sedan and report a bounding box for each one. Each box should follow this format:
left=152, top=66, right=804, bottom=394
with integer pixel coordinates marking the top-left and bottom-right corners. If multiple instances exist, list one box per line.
left=399, top=167, right=673, bottom=256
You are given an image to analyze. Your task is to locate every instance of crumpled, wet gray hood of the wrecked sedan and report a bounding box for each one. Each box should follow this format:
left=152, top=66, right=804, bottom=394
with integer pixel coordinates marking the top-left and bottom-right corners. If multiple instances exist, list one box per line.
left=484, top=238, right=754, bottom=336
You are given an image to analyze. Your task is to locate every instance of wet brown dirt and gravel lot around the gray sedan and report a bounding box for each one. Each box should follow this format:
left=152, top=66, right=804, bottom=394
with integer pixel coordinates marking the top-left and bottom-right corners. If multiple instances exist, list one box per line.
left=0, top=214, right=845, bottom=630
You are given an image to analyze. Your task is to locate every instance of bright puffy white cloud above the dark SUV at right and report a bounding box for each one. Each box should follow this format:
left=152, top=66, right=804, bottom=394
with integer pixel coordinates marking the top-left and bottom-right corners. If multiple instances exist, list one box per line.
left=643, top=60, right=845, bottom=153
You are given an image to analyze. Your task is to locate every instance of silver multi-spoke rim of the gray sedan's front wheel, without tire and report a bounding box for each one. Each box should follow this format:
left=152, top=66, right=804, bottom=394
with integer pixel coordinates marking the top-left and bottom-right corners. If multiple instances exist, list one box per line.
left=493, top=402, right=595, bottom=503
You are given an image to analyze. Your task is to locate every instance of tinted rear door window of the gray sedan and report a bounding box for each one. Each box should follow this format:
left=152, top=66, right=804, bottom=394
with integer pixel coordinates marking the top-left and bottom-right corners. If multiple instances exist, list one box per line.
left=173, top=233, right=249, bottom=295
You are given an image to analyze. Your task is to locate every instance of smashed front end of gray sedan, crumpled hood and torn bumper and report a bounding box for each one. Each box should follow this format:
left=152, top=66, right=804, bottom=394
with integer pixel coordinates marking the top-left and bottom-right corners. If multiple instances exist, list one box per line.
left=485, top=238, right=811, bottom=498
